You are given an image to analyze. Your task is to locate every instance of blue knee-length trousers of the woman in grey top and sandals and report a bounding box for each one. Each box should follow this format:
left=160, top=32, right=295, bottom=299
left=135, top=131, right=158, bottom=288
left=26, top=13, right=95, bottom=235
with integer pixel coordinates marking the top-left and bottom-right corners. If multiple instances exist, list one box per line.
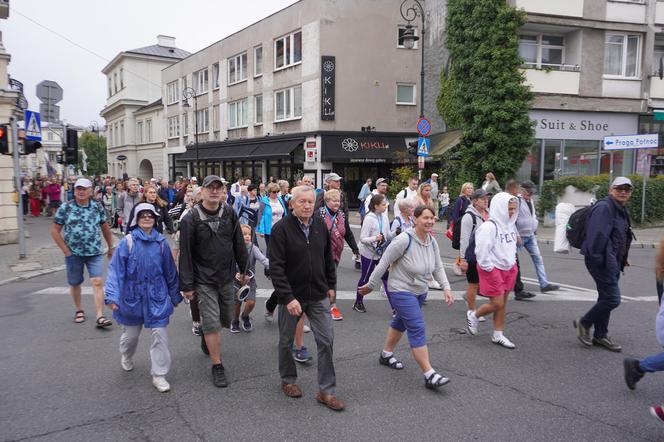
left=390, top=292, right=427, bottom=348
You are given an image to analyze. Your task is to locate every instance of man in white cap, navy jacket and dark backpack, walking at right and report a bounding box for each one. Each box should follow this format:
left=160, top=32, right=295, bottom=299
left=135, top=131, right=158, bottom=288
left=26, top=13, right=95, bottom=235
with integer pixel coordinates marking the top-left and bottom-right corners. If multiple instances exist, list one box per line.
left=573, top=177, right=634, bottom=352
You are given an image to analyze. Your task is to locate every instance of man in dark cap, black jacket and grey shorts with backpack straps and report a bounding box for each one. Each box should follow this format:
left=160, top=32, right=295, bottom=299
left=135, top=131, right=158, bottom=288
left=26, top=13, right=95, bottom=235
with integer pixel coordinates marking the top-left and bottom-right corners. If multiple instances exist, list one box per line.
left=180, top=175, right=249, bottom=387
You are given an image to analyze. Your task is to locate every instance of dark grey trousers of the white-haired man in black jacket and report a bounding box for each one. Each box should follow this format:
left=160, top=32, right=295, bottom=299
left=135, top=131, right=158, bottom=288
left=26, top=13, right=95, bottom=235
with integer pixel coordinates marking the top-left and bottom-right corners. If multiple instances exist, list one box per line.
left=279, top=299, right=337, bottom=394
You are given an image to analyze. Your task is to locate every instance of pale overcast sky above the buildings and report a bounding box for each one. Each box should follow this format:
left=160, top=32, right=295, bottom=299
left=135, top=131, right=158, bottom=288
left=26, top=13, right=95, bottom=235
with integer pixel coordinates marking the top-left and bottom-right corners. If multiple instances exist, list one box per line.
left=0, top=0, right=295, bottom=126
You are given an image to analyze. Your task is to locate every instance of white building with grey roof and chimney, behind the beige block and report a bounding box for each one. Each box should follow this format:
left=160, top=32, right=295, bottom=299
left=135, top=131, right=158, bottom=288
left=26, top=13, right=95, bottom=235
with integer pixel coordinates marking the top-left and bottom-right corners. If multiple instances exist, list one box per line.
left=100, top=35, right=189, bottom=176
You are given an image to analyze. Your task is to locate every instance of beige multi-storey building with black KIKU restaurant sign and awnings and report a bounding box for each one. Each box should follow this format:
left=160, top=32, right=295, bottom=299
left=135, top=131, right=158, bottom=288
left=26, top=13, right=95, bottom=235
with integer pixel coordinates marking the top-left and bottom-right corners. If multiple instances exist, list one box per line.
left=162, top=0, right=421, bottom=199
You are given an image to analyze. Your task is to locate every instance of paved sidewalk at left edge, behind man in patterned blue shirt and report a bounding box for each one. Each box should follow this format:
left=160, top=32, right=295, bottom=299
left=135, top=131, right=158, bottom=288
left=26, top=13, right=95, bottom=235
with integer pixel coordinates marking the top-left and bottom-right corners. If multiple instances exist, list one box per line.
left=0, top=216, right=118, bottom=285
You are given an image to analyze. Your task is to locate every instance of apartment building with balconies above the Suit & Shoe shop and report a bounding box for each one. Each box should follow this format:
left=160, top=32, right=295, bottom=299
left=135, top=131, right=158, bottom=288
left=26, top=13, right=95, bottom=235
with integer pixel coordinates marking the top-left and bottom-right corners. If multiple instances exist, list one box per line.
left=510, top=0, right=664, bottom=185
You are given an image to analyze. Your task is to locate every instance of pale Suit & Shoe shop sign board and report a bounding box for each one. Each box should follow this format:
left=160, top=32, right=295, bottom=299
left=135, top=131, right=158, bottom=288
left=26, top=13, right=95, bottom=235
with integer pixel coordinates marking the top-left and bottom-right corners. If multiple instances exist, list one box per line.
left=530, top=110, right=638, bottom=140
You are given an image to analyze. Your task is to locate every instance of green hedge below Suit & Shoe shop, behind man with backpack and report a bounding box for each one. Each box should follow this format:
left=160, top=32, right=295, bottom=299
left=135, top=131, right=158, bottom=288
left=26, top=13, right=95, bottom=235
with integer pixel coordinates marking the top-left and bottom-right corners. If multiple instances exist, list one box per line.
left=538, top=175, right=664, bottom=223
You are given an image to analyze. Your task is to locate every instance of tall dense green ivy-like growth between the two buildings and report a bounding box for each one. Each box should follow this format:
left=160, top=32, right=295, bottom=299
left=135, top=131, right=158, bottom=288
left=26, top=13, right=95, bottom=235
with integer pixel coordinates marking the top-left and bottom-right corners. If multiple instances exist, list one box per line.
left=437, top=0, right=533, bottom=186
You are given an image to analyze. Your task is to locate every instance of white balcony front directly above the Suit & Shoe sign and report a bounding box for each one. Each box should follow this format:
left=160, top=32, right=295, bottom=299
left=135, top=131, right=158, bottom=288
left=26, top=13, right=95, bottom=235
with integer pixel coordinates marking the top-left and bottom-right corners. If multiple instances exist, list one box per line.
left=523, top=64, right=581, bottom=95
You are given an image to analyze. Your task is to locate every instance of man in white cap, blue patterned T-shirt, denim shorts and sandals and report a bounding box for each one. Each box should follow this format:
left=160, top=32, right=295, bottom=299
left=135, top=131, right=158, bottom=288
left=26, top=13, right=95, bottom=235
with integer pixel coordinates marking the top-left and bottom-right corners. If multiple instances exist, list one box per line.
left=51, top=178, right=113, bottom=328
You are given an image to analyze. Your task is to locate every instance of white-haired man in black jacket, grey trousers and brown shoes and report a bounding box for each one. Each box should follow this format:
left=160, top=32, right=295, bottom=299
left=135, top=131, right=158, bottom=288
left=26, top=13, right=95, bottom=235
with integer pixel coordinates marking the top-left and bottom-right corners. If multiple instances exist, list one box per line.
left=268, top=186, right=345, bottom=411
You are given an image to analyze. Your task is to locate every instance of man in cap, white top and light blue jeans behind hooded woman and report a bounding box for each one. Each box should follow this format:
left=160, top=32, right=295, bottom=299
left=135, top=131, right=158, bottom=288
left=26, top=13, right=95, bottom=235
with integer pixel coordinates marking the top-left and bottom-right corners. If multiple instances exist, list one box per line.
left=516, top=180, right=560, bottom=293
